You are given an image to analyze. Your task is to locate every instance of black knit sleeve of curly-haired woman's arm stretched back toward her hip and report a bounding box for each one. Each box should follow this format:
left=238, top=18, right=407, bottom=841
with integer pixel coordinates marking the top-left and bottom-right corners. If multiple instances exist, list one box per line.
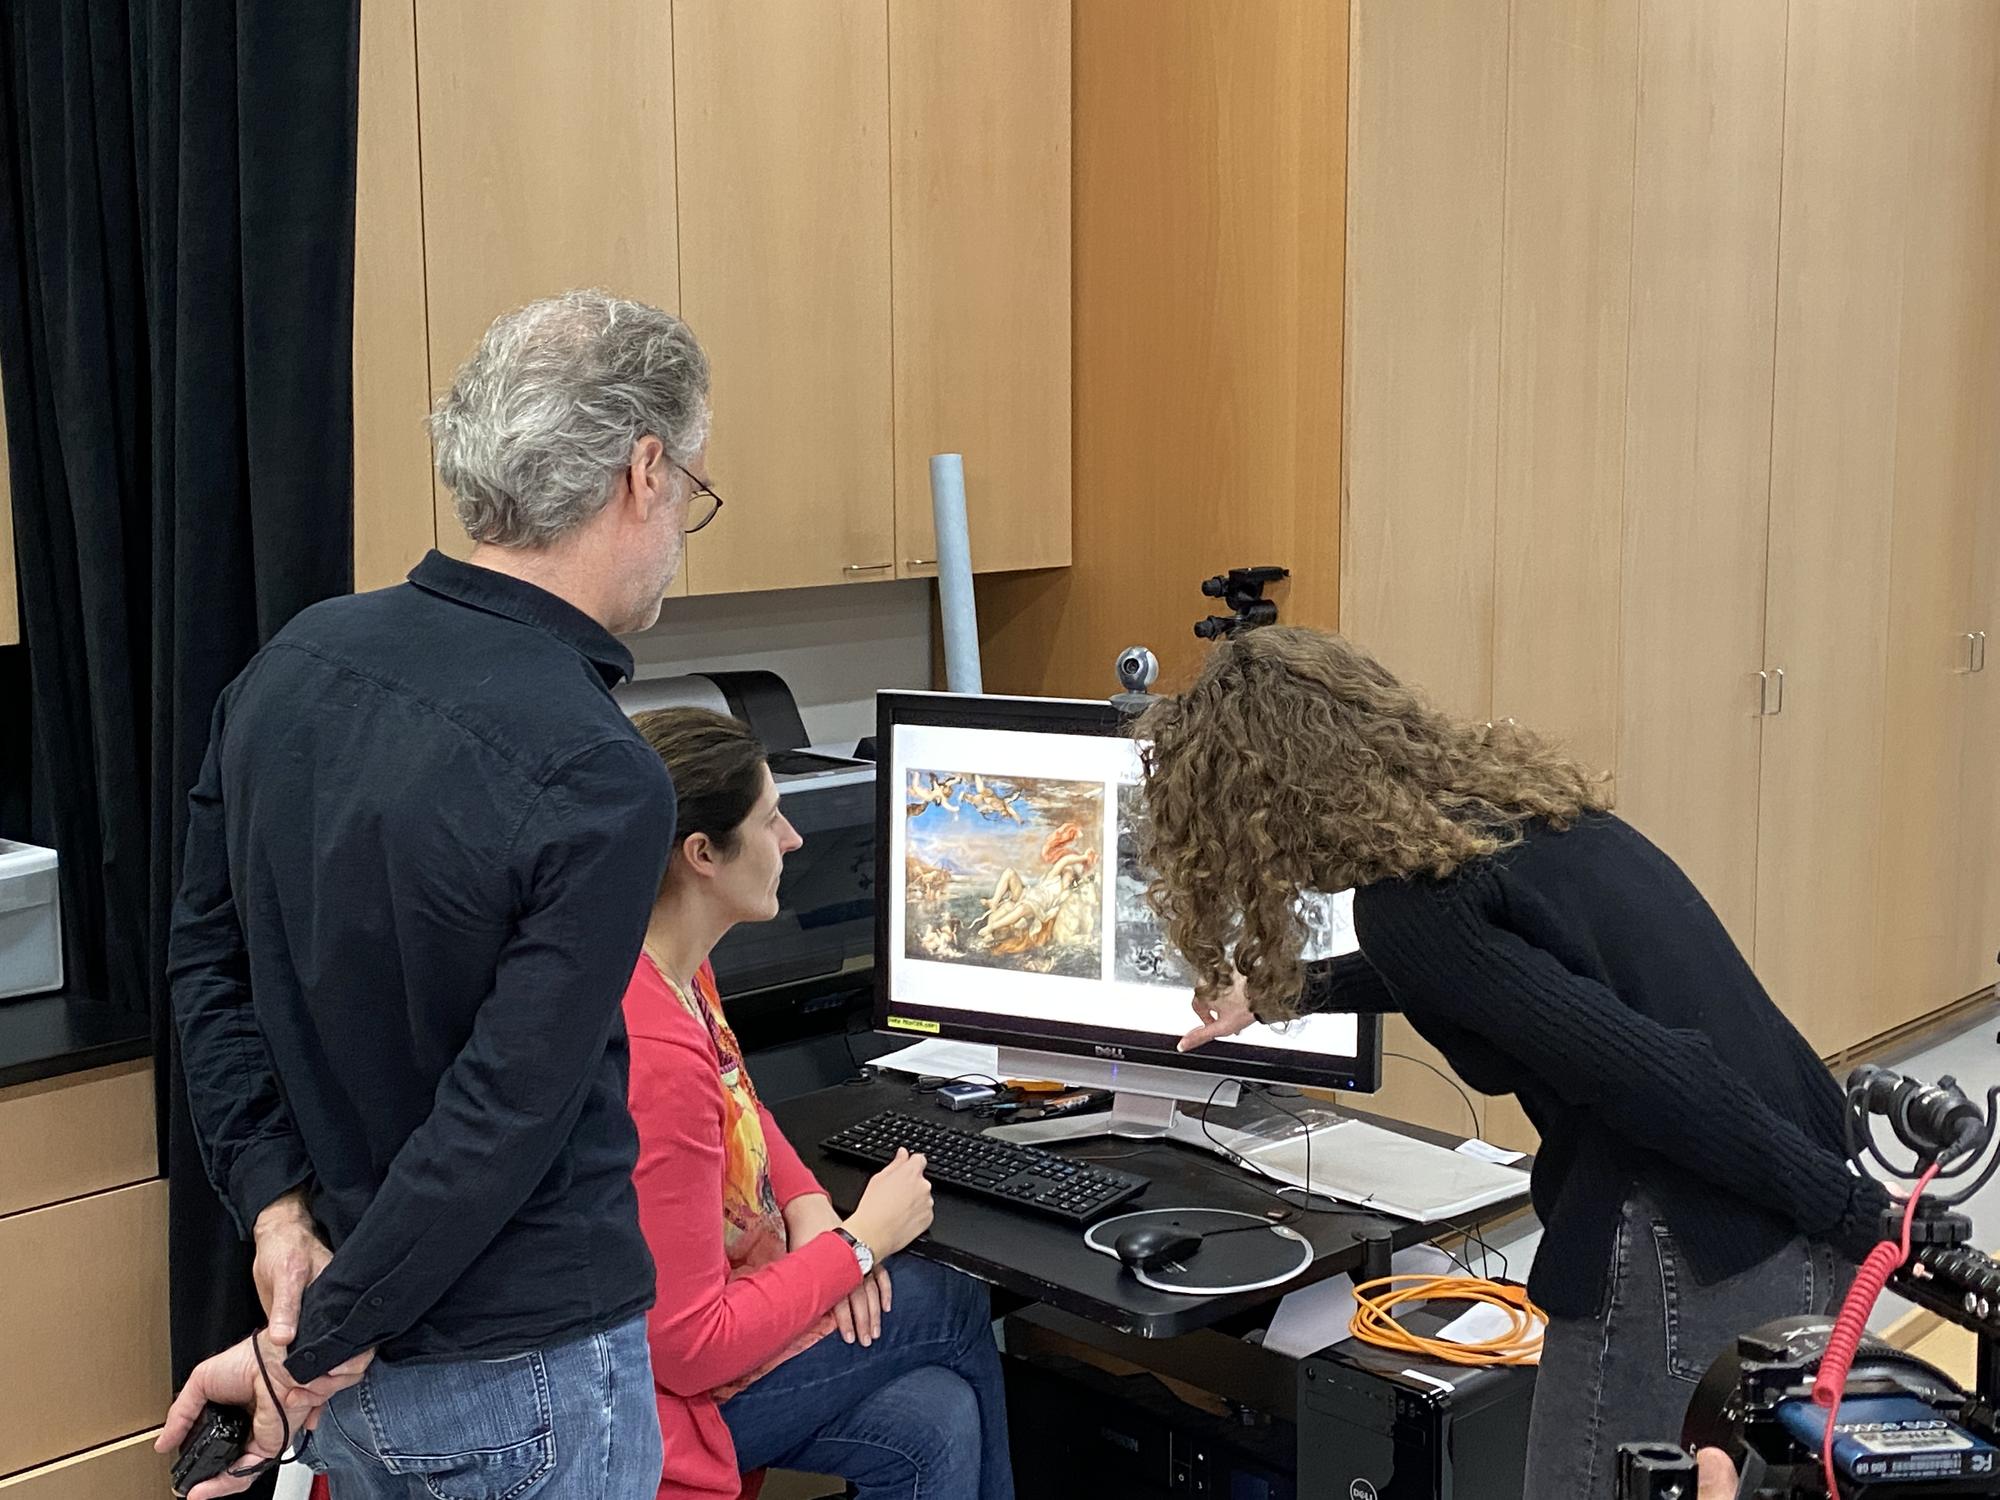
left=1356, top=870, right=1886, bottom=1246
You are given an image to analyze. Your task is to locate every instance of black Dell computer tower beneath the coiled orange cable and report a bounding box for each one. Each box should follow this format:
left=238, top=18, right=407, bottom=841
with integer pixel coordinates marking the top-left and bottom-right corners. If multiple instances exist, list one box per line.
left=1298, top=1306, right=1534, bottom=1500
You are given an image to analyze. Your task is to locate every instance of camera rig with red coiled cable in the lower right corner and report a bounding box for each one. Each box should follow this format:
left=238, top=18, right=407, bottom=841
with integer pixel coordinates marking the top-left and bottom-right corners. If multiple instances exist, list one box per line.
left=1618, top=1066, right=2000, bottom=1500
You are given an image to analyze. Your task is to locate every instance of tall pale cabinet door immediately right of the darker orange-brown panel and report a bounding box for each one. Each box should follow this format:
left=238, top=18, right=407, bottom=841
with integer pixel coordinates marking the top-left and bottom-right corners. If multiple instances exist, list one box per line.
left=1340, top=0, right=1508, bottom=718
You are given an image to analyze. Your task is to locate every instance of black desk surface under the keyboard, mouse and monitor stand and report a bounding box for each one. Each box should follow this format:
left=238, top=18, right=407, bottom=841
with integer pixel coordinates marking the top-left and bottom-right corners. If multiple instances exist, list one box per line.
left=772, top=1078, right=1526, bottom=1338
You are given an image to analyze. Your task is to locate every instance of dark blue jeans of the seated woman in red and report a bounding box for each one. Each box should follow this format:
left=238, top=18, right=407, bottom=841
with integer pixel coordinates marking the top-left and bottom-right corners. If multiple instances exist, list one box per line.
left=722, top=1256, right=1014, bottom=1500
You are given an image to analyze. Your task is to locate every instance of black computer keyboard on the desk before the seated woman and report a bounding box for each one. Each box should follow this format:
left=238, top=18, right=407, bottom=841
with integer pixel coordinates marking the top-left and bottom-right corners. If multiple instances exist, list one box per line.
left=820, top=1110, right=1148, bottom=1224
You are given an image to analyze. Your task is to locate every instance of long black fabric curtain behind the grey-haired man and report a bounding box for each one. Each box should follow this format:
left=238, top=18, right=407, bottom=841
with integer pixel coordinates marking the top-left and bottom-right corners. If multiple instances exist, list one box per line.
left=0, top=0, right=360, bottom=1424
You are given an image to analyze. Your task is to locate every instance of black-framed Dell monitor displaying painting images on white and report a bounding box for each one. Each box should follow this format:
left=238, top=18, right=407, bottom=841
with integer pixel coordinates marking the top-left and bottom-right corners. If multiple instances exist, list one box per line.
left=876, top=692, right=1382, bottom=1090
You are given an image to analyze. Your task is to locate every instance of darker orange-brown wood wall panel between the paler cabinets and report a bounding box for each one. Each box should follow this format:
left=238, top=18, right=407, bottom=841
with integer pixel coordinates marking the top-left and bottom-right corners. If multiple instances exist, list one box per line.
left=978, top=0, right=1348, bottom=696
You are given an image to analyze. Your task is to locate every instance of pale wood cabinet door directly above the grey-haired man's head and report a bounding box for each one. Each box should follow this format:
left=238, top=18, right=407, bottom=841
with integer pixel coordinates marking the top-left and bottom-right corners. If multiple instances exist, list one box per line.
left=416, top=0, right=684, bottom=592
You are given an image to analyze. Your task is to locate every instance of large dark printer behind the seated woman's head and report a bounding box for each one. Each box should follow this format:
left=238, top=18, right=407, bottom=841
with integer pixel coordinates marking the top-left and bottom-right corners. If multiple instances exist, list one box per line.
left=618, top=672, right=878, bottom=1100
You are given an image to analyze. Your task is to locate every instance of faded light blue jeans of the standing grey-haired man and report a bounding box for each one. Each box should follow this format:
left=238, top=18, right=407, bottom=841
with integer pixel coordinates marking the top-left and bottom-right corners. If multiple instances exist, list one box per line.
left=304, top=1318, right=660, bottom=1500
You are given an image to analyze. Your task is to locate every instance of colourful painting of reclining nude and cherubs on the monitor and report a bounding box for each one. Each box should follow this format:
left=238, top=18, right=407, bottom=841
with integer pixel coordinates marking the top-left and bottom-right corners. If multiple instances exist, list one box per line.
left=904, top=770, right=1104, bottom=978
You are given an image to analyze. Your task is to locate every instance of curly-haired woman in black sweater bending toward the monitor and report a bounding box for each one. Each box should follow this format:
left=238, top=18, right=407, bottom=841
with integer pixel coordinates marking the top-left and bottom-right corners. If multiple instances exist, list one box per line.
left=1138, top=626, right=1888, bottom=1500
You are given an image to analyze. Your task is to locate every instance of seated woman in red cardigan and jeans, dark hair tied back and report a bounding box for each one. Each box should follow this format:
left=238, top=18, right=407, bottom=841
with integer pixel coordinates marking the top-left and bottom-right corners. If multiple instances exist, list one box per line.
left=624, top=708, right=1014, bottom=1500
